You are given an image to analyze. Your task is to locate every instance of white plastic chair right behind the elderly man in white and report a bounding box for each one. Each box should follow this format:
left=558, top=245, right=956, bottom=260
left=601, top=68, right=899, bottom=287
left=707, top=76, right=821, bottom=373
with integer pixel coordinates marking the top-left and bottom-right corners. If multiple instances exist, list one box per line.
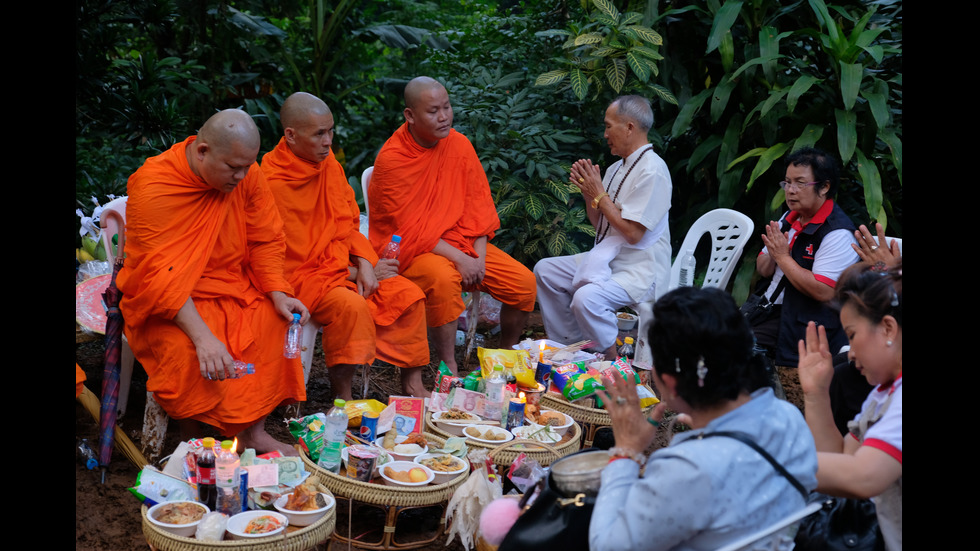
left=633, top=209, right=755, bottom=369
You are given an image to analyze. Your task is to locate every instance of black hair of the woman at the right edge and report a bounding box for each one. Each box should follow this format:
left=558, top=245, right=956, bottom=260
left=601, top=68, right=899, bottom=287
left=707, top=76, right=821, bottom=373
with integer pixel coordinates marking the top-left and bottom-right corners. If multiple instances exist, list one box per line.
left=834, top=260, right=902, bottom=327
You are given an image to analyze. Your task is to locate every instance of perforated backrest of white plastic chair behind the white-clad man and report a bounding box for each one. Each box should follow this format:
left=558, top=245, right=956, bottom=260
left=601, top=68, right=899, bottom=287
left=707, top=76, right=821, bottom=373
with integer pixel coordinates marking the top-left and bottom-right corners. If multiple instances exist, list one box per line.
left=657, top=209, right=755, bottom=296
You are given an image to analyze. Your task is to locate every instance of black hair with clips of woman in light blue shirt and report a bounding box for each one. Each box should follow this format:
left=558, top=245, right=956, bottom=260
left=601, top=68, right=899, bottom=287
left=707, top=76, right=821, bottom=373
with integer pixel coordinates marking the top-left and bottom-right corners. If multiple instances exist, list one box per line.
left=649, top=287, right=767, bottom=408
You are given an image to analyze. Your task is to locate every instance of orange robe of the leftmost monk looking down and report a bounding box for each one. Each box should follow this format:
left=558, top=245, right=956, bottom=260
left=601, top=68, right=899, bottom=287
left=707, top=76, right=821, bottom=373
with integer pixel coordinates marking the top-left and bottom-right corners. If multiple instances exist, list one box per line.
left=117, top=137, right=306, bottom=436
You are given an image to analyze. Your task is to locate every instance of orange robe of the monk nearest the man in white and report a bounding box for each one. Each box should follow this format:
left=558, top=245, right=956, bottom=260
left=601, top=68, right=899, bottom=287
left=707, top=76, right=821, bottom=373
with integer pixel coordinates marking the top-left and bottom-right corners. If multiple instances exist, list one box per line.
left=368, top=124, right=536, bottom=327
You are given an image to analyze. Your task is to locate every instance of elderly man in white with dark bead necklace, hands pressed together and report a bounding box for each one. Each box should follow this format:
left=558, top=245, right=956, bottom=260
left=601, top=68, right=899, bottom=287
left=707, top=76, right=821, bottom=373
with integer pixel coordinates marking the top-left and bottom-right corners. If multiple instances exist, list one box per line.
left=534, top=96, right=671, bottom=359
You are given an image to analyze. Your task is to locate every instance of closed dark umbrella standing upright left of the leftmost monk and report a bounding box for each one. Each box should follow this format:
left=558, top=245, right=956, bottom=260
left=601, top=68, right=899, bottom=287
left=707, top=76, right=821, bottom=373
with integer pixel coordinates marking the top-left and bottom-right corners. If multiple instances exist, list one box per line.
left=99, top=255, right=123, bottom=482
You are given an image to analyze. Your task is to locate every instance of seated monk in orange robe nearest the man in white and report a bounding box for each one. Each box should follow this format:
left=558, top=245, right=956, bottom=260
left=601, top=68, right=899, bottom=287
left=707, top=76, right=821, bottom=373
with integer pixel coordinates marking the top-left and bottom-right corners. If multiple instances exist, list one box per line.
left=368, top=77, right=536, bottom=373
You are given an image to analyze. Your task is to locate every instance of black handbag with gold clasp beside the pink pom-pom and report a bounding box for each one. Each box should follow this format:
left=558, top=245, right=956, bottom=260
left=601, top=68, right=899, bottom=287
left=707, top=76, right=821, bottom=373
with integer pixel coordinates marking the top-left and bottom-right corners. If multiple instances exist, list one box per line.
left=498, top=473, right=596, bottom=551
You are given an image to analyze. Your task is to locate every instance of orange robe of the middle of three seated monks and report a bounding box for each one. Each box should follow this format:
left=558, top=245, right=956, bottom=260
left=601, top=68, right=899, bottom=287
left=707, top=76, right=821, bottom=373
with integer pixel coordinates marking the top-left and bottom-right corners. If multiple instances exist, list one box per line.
left=262, top=138, right=429, bottom=367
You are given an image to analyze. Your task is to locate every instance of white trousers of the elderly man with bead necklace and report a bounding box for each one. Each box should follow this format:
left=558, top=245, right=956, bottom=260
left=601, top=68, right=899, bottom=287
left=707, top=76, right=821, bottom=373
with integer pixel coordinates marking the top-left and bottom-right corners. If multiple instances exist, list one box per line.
left=534, top=253, right=633, bottom=350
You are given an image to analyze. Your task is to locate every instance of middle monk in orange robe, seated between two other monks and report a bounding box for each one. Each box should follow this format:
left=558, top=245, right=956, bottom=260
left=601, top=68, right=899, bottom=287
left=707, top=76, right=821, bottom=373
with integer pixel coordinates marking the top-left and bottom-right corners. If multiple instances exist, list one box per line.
left=262, top=92, right=429, bottom=400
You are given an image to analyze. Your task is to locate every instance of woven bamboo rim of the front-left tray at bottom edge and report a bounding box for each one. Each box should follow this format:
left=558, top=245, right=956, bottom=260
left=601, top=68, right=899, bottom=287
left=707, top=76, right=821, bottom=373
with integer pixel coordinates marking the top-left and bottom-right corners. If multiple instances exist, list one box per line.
left=142, top=484, right=337, bottom=551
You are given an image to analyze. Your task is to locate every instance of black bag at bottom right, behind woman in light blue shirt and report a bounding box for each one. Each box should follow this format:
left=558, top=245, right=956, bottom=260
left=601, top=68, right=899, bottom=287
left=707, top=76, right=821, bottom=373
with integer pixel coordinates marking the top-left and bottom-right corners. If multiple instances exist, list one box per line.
left=794, top=497, right=885, bottom=551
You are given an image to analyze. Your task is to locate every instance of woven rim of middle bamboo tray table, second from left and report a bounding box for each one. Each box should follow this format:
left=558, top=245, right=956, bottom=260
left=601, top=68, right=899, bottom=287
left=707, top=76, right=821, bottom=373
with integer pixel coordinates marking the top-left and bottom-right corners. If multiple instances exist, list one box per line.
left=300, top=432, right=470, bottom=507
